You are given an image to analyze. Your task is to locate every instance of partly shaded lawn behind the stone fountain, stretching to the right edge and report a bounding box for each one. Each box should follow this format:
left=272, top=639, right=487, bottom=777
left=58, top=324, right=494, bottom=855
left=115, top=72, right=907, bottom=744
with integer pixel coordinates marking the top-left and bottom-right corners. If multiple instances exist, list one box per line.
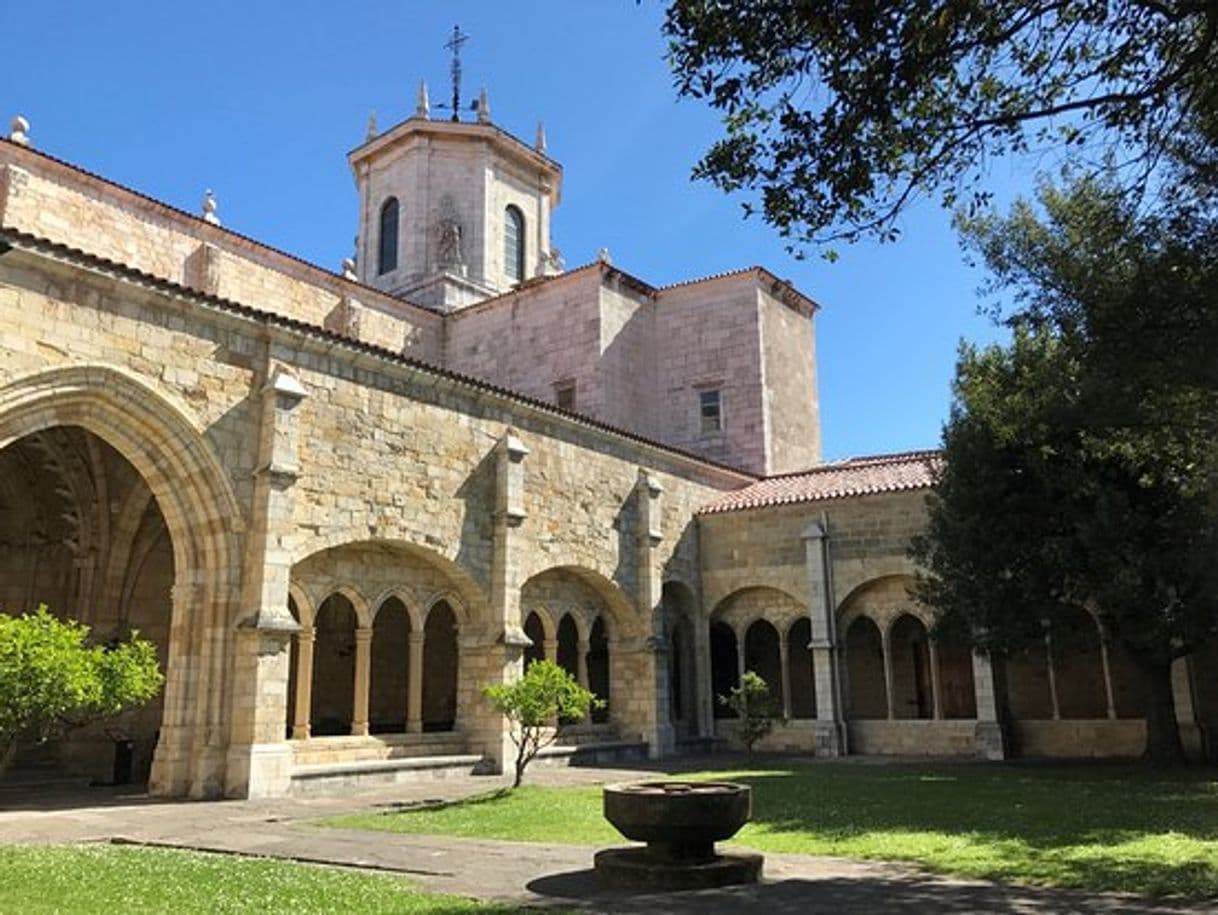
left=326, top=760, right=1218, bottom=898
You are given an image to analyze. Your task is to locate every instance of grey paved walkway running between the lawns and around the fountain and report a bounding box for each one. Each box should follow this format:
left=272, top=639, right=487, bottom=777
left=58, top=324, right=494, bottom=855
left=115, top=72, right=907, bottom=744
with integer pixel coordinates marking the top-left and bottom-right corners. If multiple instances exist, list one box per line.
left=0, top=769, right=1218, bottom=915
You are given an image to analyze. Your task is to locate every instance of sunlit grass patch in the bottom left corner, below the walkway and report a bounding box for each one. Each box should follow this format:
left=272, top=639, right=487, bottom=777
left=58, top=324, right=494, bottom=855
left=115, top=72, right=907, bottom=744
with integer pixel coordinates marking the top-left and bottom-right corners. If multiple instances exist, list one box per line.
left=0, top=844, right=515, bottom=915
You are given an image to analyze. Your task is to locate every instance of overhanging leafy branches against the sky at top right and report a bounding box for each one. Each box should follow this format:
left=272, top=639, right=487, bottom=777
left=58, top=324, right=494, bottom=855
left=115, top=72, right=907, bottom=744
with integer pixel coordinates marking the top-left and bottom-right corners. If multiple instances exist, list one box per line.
left=665, top=0, right=1218, bottom=247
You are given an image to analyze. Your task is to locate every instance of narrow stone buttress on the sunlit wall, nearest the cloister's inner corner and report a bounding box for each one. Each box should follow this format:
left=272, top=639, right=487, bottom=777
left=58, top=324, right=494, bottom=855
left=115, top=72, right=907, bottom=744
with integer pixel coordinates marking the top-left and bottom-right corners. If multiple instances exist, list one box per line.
left=633, top=468, right=676, bottom=759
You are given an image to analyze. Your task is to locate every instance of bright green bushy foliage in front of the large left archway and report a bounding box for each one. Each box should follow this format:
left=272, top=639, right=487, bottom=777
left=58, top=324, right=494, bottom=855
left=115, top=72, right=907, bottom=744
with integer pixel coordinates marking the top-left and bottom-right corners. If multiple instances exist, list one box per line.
left=0, top=604, right=164, bottom=771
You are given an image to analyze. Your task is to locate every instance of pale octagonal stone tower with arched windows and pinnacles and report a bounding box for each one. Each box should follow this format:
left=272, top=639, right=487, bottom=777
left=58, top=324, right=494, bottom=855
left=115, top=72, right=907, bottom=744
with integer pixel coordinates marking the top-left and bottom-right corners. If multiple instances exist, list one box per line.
left=347, top=73, right=563, bottom=313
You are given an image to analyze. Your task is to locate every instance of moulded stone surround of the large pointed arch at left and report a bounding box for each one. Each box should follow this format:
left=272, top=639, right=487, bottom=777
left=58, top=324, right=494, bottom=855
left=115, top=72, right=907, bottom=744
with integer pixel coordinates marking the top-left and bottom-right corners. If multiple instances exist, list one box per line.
left=0, top=364, right=244, bottom=797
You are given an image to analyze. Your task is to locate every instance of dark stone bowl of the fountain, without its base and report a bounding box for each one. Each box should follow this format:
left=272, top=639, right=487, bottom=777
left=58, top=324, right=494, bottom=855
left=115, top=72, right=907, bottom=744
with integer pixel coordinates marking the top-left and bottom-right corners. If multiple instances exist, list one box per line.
left=603, top=781, right=753, bottom=854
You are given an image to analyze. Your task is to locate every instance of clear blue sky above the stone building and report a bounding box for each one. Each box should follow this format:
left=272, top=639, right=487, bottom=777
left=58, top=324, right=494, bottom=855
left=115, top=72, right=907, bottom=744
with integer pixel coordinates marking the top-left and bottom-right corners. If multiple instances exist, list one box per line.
left=0, top=0, right=1027, bottom=458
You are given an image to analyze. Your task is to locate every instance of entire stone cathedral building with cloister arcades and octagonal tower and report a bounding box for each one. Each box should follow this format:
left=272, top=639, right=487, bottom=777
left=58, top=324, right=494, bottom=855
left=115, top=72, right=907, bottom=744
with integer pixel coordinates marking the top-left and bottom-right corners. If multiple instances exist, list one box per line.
left=0, top=87, right=1218, bottom=797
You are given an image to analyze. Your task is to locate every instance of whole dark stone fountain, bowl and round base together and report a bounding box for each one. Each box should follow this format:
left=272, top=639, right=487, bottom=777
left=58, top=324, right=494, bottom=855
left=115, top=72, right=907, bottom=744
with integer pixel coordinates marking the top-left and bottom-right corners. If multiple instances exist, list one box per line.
left=593, top=781, right=762, bottom=889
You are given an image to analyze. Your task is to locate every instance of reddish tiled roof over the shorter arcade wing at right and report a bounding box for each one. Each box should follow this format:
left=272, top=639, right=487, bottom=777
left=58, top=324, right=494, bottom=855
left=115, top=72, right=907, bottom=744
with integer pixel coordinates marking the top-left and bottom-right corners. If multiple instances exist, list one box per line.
left=698, top=451, right=943, bottom=514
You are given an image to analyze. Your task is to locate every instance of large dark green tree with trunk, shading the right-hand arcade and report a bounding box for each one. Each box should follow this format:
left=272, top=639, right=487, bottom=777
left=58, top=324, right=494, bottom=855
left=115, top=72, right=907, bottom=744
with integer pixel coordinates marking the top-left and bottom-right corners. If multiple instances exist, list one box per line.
left=914, top=179, right=1218, bottom=763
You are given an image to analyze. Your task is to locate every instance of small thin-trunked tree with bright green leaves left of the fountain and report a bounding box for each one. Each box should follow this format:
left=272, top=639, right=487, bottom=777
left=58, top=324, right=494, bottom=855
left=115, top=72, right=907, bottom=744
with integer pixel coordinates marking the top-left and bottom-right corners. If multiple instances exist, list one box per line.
left=482, top=660, right=604, bottom=788
